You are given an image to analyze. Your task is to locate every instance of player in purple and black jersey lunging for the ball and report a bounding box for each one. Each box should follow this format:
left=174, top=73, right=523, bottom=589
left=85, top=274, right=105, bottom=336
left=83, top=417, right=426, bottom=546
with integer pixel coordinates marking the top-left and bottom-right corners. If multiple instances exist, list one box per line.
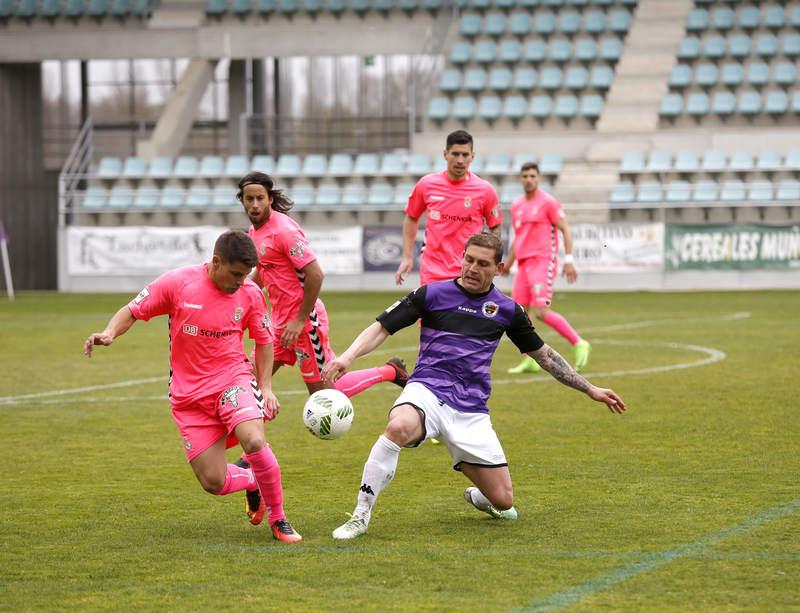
left=323, top=232, right=625, bottom=539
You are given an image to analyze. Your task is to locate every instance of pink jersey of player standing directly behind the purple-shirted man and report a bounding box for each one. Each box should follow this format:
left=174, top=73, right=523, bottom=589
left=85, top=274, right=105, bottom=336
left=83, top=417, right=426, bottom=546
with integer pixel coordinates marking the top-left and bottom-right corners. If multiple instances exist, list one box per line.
left=406, top=170, right=503, bottom=283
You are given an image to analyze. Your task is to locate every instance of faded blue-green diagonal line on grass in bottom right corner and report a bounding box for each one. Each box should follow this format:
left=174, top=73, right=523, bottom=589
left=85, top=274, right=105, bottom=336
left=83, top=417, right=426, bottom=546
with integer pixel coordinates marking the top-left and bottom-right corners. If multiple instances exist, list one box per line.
left=521, top=498, right=800, bottom=613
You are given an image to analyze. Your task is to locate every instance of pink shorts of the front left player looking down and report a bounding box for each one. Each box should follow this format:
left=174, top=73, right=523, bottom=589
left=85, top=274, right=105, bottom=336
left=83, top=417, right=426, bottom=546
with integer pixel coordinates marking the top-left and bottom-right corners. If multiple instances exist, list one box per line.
left=172, top=375, right=265, bottom=462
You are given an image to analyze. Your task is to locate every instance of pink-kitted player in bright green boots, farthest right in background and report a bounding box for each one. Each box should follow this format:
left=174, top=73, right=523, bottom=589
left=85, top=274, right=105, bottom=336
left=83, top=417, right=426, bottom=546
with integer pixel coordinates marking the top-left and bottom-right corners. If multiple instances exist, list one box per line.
left=502, top=162, right=592, bottom=374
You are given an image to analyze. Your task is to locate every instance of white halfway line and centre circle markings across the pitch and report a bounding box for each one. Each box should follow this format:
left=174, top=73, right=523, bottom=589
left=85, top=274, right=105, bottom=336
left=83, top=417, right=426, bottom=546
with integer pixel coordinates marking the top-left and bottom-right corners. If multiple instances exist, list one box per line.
left=0, top=312, right=750, bottom=406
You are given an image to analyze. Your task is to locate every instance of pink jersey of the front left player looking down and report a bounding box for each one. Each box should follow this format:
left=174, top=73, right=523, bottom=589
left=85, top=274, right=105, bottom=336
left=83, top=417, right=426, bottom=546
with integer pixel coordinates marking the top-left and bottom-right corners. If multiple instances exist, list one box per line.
left=128, top=264, right=273, bottom=406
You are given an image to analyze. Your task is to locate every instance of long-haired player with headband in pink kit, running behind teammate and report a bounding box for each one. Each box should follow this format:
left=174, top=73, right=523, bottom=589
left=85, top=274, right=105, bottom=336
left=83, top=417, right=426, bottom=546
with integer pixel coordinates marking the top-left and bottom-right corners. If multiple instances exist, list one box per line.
left=237, top=172, right=408, bottom=397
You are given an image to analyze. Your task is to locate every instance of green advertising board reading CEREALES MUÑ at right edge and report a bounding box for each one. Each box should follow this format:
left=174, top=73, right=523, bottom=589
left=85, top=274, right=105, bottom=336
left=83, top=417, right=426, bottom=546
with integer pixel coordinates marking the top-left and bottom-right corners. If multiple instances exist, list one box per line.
left=664, top=224, right=800, bottom=271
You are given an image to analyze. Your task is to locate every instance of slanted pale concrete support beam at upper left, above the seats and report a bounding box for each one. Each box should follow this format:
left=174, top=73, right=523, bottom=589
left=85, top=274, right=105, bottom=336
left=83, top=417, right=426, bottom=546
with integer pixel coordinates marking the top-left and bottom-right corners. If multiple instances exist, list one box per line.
left=136, top=59, right=217, bottom=160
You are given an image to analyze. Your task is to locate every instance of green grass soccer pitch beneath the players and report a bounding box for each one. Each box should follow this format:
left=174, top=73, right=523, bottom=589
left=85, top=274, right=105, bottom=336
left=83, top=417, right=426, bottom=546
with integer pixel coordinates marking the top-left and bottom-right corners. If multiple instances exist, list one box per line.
left=0, top=292, right=800, bottom=611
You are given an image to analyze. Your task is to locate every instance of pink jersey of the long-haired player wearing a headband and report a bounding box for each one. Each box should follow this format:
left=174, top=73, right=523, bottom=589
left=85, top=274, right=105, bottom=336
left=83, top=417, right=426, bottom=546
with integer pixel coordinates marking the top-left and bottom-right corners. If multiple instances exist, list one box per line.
left=247, top=211, right=321, bottom=330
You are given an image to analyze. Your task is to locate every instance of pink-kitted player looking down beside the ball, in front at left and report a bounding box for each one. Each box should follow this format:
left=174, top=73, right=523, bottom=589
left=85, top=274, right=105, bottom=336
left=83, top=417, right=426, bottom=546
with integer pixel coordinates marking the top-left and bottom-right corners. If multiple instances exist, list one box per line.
left=83, top=231, right=302, bottom=543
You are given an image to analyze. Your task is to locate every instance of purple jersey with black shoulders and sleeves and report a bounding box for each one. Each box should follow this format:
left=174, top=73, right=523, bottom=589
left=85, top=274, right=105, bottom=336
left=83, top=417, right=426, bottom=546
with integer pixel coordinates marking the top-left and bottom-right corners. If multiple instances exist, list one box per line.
left=377, top=280, right=544, bottom=413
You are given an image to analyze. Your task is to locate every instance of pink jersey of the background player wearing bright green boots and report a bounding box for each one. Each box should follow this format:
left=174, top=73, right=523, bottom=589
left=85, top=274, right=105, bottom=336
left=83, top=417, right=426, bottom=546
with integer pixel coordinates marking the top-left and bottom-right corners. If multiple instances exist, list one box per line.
left=511, top=189, right=564, bottom=260
